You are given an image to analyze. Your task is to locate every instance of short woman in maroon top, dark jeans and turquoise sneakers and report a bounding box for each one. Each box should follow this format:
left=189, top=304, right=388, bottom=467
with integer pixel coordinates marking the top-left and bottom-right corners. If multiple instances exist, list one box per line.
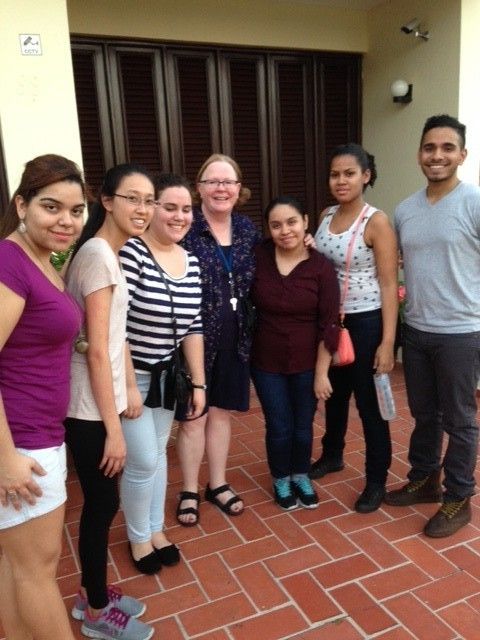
left=252, top=196, right=339, bottom=510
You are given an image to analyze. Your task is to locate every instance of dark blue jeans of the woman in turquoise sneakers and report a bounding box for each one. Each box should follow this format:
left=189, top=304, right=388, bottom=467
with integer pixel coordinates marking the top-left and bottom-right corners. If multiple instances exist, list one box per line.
left=251, top=367, right=317, bottom=478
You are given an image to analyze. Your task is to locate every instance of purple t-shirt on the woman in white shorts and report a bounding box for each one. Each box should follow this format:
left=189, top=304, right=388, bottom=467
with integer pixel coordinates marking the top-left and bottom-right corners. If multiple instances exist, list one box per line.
left=0, top=240, right=82, bottom=449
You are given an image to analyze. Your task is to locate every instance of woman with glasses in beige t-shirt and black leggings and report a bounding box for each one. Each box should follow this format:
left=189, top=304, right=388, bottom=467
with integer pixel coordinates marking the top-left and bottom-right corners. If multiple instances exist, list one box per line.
left=65, top=164, right=155, bottom=640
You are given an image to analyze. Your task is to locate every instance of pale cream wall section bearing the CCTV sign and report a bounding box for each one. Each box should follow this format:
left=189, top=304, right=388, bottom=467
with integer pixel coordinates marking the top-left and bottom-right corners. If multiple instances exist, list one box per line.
left=0, top=0, right=82, bottom=192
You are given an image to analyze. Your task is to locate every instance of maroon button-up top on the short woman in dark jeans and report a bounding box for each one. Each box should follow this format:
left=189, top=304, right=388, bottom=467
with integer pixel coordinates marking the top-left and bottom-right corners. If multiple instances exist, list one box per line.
left=252, top=240, right=339, bottom=374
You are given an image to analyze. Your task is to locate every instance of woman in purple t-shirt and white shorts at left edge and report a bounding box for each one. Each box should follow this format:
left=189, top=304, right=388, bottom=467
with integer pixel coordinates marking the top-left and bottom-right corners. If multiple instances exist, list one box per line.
left=0, top=155, right=85, bottom=640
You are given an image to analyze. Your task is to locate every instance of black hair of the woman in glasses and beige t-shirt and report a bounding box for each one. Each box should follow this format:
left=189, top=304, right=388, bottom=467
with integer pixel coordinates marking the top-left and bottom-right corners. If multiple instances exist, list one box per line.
left=70, top=162, right=155, bottom=264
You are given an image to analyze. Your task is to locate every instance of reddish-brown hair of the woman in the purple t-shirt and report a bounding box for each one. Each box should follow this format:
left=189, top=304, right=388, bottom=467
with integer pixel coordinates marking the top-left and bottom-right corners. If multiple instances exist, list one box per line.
left=0, top=153, right=89, bottom=238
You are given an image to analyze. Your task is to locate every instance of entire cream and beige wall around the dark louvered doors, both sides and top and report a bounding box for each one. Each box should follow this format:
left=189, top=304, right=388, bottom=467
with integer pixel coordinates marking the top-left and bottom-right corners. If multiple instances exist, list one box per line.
left=0, top=0, right=468, bottom=212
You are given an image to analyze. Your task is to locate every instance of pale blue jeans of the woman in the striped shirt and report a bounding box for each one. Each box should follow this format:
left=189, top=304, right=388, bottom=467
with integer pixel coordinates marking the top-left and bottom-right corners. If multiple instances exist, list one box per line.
left=120, top=372, right=175, bottom=543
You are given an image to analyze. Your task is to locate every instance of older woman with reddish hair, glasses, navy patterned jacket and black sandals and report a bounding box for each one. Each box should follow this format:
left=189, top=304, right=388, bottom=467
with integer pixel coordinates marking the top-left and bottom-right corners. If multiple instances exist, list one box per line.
left=177, top=154, right=260, bottom=527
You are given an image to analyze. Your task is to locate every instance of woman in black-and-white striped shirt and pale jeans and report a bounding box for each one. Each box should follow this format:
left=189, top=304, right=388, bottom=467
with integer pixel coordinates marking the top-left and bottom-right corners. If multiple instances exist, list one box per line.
left=120, top=174, right=206, bottom=574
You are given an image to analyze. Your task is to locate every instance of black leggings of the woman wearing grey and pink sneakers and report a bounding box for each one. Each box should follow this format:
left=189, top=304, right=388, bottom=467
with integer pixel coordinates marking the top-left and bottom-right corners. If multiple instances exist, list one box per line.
left=65, top=418, right=120, bottom=609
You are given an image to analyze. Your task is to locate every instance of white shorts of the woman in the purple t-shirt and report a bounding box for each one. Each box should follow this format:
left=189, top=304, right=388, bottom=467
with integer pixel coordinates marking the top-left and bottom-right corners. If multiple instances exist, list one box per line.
left=0, top=443, right=67, bottom=529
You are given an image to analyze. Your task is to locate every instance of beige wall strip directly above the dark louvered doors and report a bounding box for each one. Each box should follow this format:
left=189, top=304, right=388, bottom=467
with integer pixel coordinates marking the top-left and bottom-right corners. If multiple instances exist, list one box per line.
left=68, top=0, right=367, bottom=51
